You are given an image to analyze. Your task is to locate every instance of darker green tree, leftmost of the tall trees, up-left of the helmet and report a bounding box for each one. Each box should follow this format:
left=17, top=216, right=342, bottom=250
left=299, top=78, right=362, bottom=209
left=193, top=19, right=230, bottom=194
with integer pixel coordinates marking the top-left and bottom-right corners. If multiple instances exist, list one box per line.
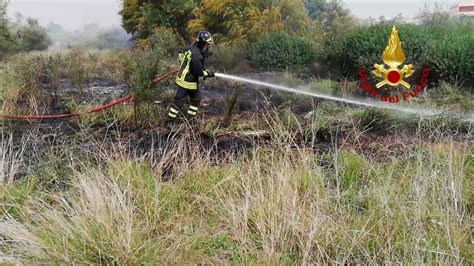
left=120, top=0, right=199, bottom=39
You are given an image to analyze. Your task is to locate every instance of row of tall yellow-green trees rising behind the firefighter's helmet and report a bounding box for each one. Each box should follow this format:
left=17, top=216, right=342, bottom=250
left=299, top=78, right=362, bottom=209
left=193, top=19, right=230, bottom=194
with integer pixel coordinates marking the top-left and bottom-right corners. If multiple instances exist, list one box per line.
left=120, top=0, right=355, bottom=44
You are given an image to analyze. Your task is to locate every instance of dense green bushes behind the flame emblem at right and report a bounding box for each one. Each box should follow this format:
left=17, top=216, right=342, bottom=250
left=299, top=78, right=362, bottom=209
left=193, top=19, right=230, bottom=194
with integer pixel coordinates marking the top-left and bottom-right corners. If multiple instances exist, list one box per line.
left=318, top=15, right=474, bottom=82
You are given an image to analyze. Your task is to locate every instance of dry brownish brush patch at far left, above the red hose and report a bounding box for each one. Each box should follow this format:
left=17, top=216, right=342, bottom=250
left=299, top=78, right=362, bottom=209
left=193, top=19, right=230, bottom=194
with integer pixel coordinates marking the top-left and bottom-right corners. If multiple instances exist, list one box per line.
left=0, top=49, right=132, bottom=114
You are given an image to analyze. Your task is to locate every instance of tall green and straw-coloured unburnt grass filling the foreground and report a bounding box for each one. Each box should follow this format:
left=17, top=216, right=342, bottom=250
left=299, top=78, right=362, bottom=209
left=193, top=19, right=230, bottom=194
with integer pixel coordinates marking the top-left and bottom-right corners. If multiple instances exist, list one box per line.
left=0, top=108, right=474, bottom=264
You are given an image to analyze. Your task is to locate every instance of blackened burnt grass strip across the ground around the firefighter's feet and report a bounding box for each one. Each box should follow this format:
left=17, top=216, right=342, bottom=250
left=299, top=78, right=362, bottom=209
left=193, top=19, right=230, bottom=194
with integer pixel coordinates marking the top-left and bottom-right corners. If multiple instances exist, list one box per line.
left=1, top=73, right=470, bottom=181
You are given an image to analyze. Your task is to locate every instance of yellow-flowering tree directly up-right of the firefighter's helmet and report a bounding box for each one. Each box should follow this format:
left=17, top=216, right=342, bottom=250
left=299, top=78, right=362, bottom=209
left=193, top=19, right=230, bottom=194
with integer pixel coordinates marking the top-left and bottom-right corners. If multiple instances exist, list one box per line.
left=188, top=0, right=308, bottom=44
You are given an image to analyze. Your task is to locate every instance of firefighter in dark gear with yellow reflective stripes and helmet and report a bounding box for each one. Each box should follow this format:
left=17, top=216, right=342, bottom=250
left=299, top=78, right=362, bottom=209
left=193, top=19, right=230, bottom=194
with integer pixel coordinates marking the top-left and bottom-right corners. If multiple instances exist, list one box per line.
left=166, top=31, right=214, bottom=128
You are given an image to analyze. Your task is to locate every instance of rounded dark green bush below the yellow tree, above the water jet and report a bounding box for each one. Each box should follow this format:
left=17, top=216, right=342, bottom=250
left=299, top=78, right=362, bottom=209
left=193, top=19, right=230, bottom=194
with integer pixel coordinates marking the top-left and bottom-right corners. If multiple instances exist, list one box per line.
left=247, top=32, right=315, bottom=70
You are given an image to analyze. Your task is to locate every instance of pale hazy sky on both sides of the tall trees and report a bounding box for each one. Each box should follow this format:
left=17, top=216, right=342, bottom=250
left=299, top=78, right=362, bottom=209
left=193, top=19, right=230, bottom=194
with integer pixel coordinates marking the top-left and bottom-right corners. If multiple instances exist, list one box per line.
left=8, top=0, right=472, bottom=30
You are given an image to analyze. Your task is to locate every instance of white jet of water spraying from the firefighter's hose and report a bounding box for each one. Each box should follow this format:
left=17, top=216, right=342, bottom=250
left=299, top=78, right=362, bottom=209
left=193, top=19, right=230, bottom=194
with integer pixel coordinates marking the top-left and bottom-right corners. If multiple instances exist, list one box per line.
left=215, top=73, right=474, bottom=122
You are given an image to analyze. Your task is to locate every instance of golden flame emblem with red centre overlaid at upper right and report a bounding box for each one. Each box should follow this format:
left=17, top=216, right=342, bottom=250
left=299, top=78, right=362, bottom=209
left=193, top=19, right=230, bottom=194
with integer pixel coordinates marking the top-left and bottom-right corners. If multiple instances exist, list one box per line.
left=372, top=26, right=415, bottom=89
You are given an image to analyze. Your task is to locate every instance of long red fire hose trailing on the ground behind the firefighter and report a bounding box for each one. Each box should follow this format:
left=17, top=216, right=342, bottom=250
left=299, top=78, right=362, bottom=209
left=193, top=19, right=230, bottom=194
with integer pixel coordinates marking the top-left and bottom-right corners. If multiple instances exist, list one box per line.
left=0, top=69, right=179, bottom=120
